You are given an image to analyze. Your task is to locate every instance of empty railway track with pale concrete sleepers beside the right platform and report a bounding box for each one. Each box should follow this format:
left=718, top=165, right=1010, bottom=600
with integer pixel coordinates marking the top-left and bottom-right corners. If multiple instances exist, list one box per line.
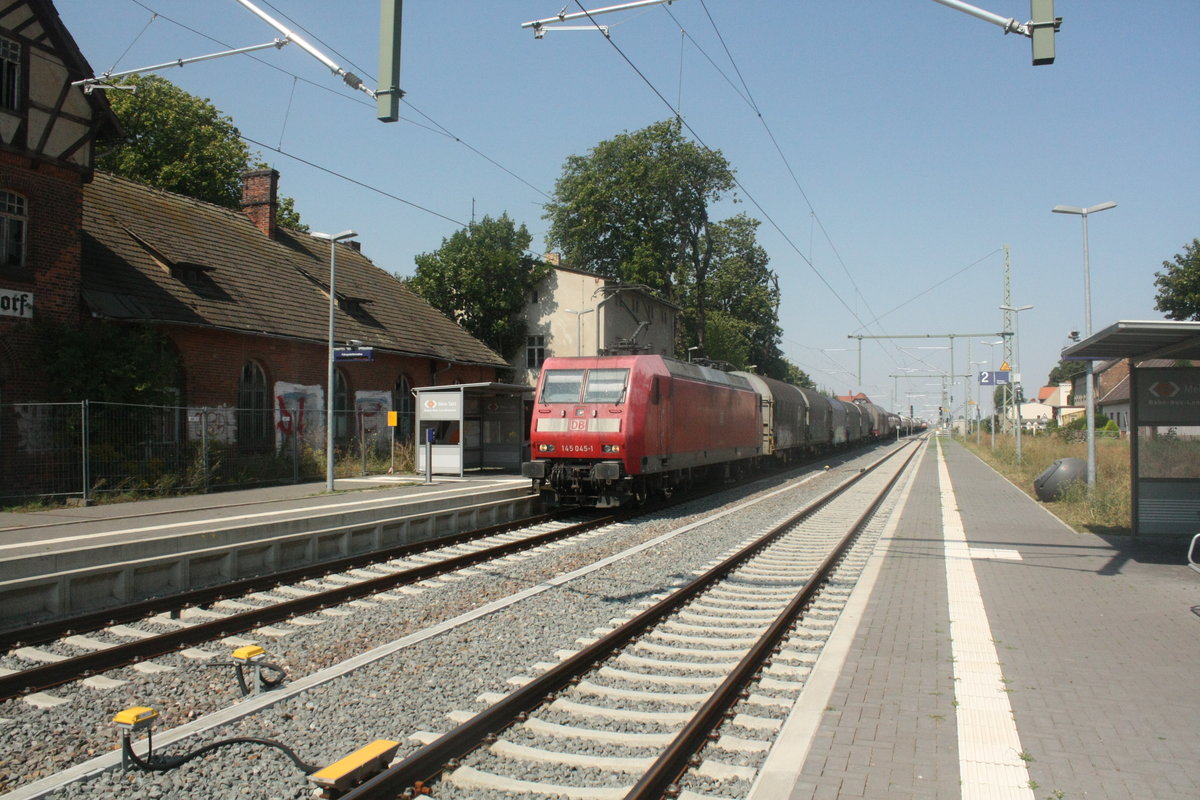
left=346, top=447, right=917, bottom=800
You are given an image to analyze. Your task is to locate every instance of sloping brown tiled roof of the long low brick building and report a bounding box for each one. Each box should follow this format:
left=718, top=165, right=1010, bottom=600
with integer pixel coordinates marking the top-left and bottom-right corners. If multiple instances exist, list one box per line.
left=83, top=173, right=508, bottom=367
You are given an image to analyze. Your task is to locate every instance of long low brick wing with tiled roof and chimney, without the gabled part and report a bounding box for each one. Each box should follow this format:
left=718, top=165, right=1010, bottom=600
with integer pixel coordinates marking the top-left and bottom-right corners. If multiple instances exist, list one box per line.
left=82, top=169, right=508, bottom=447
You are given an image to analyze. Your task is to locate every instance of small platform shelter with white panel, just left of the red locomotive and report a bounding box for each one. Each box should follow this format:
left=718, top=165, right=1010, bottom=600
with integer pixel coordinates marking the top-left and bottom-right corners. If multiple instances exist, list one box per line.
left=413, top=383, right=533, bottom=476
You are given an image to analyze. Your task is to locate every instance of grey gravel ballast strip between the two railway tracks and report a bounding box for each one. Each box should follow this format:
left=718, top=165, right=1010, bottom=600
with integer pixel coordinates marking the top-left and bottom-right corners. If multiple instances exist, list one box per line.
left=0, top=441, right=916, bottom=800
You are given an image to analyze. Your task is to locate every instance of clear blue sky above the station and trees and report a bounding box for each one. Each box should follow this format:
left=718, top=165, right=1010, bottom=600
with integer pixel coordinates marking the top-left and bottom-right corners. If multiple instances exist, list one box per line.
left=56, top=0, right=1200, bottom=419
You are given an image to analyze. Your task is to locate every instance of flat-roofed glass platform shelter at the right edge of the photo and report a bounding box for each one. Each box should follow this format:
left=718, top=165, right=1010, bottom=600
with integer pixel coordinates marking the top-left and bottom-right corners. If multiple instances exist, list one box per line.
left=1062, top=320, right=1200, bottom=539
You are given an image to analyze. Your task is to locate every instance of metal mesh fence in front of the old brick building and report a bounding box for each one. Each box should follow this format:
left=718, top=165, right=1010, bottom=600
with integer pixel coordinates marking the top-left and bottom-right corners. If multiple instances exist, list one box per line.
left=0, top=401, right=404, bottom=504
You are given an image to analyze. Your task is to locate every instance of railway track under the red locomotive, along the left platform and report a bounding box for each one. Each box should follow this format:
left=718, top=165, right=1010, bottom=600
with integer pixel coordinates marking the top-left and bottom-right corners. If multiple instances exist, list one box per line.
left=0, top=515, right=619, bottom=704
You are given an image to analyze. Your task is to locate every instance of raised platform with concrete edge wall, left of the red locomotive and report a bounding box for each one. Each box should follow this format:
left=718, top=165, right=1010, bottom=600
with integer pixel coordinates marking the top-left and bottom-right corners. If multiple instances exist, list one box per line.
left=0, top=471, right=541, bottom=631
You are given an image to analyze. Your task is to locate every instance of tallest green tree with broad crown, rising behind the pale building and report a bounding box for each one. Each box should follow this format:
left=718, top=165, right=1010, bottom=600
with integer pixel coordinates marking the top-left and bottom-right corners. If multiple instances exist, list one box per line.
left=545, top=120, right=734, bottom=347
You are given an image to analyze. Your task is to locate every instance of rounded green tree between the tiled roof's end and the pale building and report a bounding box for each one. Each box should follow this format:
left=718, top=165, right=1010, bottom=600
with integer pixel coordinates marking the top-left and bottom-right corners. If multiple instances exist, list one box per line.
left=408, top=213, right=550, bottom=357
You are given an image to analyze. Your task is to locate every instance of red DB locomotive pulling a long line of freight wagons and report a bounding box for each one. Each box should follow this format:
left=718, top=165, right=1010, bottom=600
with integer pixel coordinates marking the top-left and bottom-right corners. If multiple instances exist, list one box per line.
left=521, top=355, right=900, bottom=507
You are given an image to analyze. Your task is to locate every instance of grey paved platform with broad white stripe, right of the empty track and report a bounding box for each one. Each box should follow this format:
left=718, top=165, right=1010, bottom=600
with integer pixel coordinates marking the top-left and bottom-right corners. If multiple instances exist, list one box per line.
left=750, top=438, right=1200, bottom=800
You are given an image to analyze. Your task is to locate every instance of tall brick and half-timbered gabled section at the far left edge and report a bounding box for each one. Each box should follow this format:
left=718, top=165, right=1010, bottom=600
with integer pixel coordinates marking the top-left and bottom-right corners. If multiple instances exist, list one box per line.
left=0, top=0, right=120, bottom=404
